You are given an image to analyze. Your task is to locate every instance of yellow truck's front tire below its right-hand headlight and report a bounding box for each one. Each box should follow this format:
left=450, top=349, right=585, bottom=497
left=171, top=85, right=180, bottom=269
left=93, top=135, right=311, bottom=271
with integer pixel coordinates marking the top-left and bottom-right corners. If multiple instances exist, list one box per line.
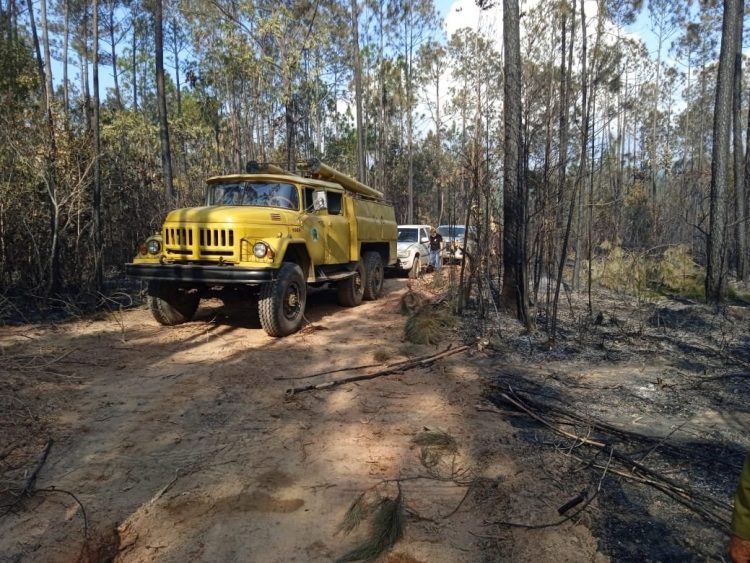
left=258, top=262, right=307, bottom=336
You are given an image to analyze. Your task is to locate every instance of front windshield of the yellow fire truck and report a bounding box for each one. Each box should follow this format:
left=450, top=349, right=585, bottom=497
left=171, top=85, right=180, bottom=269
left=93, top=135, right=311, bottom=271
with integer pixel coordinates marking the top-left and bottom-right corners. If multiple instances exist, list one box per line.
left=206, top=182, right=299, bottom=210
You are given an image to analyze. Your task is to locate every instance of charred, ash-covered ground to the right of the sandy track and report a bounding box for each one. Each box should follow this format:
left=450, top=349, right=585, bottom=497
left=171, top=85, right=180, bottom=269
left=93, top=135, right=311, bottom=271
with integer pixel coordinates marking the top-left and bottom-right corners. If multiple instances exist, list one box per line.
left=464, top=291, right=750, bottom=561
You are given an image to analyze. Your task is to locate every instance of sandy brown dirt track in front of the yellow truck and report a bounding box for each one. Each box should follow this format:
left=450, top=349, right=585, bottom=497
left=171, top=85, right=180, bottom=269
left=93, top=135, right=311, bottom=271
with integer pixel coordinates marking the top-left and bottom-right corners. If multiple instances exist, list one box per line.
left=0, top=272, right=746, bottom=562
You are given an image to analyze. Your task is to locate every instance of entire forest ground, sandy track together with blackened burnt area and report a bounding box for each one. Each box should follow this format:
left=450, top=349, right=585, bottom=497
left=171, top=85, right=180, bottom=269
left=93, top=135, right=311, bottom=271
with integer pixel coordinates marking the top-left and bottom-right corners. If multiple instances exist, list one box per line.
left=0, top=277, right=750, bottom=562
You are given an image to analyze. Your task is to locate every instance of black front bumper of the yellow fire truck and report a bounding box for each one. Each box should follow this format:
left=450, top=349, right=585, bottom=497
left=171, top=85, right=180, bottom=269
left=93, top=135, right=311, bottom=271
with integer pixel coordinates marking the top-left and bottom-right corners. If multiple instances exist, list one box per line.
left=125, top=263, right=278, bottom=285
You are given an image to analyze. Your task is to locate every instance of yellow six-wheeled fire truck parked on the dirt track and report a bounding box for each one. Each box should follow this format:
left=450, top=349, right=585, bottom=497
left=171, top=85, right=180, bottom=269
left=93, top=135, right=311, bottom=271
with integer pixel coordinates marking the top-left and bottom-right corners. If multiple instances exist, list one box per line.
left=125, top=160, right=397, bottom=336
